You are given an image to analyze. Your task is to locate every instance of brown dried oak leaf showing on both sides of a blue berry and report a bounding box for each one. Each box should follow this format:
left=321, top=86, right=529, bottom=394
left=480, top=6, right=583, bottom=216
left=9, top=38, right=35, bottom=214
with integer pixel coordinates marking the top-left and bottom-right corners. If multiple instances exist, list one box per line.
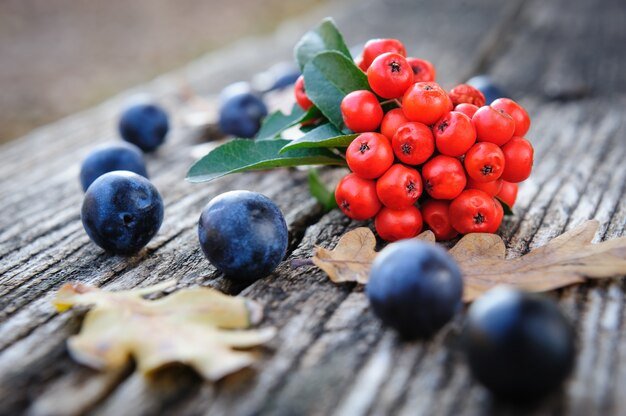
left=312, top=221, right=626, bottom=302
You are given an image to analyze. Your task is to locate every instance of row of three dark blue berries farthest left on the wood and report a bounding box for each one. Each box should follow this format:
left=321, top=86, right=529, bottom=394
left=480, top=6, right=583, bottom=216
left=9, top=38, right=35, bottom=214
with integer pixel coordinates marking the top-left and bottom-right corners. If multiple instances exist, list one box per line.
left=80, top=103, right=169, bottom=255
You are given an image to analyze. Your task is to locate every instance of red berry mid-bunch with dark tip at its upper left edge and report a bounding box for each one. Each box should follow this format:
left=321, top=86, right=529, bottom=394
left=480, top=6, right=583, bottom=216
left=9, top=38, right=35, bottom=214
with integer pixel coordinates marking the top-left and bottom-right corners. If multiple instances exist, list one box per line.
left=433, top=111, right=476, bottom=157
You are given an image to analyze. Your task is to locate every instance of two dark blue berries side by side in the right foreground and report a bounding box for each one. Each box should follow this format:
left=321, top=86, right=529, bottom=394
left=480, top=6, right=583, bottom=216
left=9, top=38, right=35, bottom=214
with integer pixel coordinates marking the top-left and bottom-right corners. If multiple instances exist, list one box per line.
left=366, top=239, right=576, bottom=402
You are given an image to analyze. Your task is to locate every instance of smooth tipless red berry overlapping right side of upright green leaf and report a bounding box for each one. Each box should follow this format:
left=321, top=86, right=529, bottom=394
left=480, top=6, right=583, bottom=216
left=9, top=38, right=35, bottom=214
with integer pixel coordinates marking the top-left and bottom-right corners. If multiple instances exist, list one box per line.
left=341, top=90, right=383, bottom=133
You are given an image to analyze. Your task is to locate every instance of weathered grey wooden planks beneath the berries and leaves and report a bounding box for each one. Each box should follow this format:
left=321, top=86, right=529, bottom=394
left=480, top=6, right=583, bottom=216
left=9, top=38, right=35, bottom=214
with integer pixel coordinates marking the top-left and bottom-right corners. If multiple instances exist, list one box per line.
left=0, top=0, right=626, bottom=415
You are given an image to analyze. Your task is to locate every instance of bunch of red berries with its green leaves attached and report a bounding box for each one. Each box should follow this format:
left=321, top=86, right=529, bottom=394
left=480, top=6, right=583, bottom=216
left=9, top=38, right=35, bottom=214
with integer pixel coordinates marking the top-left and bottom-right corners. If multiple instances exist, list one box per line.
left=188, top=19, right=533, bottom=241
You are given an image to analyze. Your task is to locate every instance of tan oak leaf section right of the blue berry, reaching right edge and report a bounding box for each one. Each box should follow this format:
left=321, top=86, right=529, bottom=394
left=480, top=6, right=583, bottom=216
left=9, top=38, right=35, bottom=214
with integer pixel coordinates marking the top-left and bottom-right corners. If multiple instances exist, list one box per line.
left=450, top=221, right=626, bottom=302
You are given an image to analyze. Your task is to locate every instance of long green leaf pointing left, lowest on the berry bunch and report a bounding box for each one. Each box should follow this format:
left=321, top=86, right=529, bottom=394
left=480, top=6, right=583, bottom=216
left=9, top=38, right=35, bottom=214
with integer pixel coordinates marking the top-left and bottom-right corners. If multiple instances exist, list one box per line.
left=187, top=139, right=346, bottom=182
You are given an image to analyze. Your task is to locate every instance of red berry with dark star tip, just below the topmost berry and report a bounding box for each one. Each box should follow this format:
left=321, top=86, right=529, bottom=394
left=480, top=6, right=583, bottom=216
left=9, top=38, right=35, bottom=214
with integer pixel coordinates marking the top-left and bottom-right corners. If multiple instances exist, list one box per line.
left=367, top=52, right=413, bottom=98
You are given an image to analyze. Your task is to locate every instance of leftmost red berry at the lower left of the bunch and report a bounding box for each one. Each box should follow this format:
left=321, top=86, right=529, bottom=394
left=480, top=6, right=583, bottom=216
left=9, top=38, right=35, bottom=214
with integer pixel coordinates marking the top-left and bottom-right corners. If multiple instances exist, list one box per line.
left=335, top=173, right=381, bottom=221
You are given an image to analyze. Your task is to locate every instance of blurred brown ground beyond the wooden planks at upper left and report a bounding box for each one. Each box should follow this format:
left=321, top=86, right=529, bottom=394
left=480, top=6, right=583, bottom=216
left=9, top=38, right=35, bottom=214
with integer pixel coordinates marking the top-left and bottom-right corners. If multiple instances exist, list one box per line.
left=0, top=0, right=324, bottom=142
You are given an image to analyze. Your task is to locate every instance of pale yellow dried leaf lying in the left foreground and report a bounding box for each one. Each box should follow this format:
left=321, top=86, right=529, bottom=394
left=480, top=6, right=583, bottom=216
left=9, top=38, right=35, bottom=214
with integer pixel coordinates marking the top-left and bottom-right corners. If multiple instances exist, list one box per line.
left=54, top=281, right=275, bottom=380
